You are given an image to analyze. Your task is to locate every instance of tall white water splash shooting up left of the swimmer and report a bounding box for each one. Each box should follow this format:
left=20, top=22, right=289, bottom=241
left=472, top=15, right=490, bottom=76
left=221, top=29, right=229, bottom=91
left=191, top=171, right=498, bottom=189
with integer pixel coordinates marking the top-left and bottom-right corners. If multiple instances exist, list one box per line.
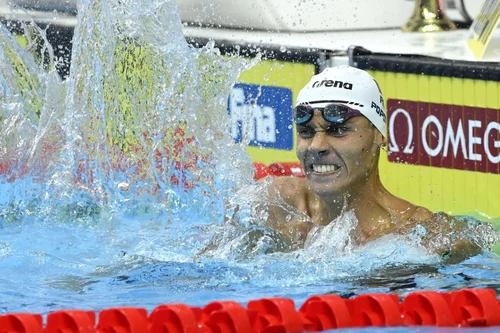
left=0, top=0, right=254, bottom=224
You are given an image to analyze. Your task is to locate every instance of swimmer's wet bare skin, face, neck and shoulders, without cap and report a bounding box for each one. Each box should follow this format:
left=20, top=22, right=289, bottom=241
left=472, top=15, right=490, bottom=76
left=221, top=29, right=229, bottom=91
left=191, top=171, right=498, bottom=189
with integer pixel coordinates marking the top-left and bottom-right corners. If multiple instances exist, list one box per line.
left=268, top=110, right=480, bottom=261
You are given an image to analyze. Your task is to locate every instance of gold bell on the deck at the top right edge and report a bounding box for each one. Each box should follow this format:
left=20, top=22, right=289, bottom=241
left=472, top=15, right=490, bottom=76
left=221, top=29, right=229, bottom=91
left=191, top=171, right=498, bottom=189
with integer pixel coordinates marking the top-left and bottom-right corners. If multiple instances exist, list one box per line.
left=401, top=0, right=457, bottom=32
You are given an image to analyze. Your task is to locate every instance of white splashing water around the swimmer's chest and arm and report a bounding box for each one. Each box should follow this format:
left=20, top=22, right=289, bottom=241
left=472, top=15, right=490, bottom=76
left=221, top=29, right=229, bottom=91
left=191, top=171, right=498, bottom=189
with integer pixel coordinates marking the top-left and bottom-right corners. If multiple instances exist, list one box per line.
left=204, top=182, right=441, bottom=274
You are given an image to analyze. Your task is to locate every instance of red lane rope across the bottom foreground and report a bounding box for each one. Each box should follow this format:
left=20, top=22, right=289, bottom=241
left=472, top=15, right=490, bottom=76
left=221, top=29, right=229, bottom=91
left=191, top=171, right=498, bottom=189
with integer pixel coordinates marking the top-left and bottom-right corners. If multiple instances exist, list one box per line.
left=0, top=289, right=500, bottom=333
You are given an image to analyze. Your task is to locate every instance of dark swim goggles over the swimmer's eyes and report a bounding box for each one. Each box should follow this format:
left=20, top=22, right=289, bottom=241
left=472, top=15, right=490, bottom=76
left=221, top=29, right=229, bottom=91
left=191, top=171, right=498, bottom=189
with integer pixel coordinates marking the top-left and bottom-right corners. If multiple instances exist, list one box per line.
left=293, top=104, right=363, bottom=125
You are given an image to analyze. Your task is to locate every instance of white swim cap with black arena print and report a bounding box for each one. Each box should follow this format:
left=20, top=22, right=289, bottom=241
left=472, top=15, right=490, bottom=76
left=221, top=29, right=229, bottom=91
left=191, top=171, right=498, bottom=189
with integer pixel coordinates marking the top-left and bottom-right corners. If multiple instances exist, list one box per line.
left=296, top=66, right=387, bottom=137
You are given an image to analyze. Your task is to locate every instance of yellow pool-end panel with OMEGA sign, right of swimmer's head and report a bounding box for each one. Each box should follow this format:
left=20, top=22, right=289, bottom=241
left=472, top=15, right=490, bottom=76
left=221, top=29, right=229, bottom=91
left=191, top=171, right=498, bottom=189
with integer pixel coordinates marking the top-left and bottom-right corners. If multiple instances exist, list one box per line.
left=371, top=71, right=500, bottom=220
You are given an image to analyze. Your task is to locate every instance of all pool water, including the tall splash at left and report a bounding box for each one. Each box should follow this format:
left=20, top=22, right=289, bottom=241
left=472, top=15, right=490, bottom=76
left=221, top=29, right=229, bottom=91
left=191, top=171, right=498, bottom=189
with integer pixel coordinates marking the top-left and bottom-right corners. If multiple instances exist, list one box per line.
left=0, top=0, right=500, bottom=332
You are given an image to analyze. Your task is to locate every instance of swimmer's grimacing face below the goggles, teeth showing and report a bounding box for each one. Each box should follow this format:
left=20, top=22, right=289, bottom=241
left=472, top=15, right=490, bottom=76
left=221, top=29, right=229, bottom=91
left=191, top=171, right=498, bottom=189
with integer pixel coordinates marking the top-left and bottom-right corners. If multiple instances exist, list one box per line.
left=297, top=110, right=382, bottom=197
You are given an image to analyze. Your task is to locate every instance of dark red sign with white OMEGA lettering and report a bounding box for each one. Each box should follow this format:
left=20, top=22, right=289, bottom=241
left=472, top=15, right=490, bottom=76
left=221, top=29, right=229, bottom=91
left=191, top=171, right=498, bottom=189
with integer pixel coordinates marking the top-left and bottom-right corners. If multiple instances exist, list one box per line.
left=387, top=100, right=500, bottom=174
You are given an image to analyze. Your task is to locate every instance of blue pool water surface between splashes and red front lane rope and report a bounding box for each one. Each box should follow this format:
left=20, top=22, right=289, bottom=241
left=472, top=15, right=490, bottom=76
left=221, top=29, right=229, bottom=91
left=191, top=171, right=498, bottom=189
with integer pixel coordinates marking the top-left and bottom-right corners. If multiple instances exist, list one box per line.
left=0, top=195, right=500, bottom=313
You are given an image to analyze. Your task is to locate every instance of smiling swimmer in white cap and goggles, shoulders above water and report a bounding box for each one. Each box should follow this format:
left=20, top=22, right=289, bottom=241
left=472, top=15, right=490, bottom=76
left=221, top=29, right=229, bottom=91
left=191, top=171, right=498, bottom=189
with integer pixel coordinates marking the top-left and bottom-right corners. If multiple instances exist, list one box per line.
left=264, top=66, right=481, bottom=262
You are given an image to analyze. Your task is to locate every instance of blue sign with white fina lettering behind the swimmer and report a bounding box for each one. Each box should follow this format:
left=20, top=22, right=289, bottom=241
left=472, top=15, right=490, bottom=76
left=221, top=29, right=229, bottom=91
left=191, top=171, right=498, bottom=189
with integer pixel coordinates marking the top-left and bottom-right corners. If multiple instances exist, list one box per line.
left=228, top=83, right=293, bottom=150
